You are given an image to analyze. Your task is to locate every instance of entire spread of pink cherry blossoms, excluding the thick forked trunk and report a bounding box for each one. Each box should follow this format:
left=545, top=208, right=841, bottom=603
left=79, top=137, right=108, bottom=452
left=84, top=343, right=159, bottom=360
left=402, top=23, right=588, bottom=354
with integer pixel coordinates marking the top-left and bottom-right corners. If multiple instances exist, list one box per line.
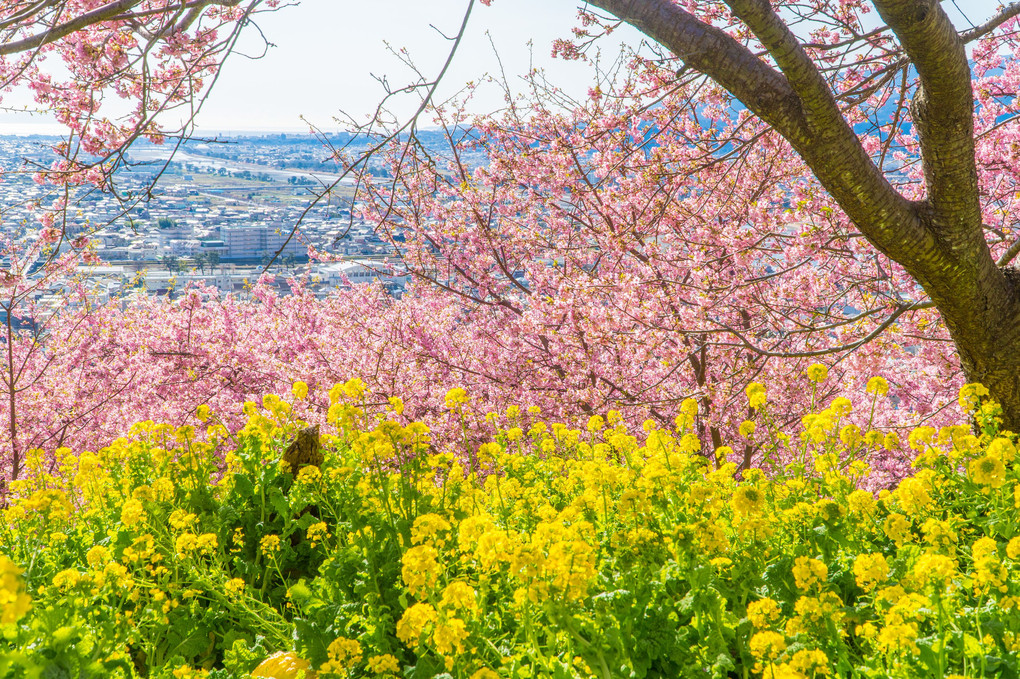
left=9, top=5, right=1020, bottom=475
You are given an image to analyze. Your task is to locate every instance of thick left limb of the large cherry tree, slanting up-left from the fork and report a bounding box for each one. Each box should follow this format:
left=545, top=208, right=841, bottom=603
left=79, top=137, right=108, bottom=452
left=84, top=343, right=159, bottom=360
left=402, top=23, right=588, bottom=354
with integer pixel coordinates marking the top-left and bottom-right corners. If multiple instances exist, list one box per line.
left=591, top=0, right=950, bottom=283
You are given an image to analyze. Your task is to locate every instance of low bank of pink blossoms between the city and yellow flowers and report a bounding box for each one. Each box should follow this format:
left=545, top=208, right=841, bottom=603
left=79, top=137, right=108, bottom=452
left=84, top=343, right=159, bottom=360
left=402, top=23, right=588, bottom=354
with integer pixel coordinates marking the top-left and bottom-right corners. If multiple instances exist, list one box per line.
left=0, top=276, right=959, bottom=482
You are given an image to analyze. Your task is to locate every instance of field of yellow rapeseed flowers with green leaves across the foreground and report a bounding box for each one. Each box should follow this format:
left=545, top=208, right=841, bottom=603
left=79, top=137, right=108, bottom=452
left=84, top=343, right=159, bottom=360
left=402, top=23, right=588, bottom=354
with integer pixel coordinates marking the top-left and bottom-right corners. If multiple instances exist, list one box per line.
left=0, top=377, right=1020, bottom=679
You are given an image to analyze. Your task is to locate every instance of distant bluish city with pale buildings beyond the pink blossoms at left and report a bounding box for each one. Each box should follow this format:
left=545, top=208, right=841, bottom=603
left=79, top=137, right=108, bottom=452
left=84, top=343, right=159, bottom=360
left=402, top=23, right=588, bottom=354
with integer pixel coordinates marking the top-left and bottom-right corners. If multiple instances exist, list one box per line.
left=0, top=129, right=478, bottom=301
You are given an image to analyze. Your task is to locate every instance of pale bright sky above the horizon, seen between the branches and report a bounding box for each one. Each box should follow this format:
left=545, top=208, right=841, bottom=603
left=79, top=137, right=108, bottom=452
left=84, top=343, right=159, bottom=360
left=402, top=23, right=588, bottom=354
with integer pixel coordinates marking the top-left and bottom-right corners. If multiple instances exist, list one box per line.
left=0, top=0, right=999, bottom=135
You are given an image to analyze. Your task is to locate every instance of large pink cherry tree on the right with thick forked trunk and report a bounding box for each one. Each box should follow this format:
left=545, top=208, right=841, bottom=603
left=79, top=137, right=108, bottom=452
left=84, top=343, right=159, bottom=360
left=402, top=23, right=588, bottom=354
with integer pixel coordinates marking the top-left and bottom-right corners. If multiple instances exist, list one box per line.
left=303, top=0, right=1020, bottom=438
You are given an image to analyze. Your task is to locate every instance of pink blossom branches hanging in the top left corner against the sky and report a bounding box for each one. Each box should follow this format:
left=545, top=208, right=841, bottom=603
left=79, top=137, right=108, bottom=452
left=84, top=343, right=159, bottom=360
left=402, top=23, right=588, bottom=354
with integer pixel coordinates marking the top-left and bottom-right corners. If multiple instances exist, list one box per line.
left=0, top=0, right=278, bottom=187
